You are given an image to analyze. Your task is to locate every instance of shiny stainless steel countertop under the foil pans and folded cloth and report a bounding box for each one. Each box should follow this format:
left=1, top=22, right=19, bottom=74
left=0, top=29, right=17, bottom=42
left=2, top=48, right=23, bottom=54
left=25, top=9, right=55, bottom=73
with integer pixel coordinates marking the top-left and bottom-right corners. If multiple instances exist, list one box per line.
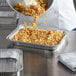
left=0, top=28, right=76, bottom=76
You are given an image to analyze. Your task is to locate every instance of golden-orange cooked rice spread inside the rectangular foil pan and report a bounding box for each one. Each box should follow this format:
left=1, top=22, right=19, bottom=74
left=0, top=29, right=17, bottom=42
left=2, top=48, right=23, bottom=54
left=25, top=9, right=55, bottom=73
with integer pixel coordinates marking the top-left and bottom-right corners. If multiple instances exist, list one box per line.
left=12, top=28, right=65, bottom=45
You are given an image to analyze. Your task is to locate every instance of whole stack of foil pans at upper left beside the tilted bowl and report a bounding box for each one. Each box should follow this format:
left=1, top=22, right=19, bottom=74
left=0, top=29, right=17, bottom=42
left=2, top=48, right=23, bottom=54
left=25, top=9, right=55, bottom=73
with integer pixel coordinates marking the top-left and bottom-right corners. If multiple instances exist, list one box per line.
left=0, top=0, right=19, bottom=27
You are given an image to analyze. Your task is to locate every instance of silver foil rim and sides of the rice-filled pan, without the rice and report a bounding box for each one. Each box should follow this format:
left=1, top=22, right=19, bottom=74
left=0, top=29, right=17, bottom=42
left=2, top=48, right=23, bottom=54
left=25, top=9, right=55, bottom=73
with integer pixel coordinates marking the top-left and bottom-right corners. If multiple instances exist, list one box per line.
left=6, top=24, right=67, bottom=51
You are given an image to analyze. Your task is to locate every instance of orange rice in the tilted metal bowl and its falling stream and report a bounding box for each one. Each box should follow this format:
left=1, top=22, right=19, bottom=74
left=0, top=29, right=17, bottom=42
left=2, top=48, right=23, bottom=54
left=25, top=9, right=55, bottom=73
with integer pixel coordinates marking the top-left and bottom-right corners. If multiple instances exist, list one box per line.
left=14, top=0, right=47, bottom=29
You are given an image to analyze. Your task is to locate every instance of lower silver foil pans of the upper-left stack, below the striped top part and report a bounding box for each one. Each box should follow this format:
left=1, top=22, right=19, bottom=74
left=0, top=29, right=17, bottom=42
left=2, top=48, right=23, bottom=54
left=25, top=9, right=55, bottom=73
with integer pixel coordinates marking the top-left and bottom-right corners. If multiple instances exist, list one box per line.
left=0, top=11, right=18, bottom=26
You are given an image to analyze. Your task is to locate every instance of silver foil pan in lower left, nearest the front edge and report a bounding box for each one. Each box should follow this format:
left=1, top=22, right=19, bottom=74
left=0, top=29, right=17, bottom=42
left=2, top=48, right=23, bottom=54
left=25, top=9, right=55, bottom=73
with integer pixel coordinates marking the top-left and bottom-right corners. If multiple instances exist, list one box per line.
left=0, top=49, right=23, bottom=73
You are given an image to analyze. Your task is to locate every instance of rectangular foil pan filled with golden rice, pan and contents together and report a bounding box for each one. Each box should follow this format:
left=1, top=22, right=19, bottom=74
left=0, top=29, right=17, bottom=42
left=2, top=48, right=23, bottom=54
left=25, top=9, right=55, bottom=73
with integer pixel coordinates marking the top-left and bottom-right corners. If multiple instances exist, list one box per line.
left=7, top=25, right=67, bottom=50
